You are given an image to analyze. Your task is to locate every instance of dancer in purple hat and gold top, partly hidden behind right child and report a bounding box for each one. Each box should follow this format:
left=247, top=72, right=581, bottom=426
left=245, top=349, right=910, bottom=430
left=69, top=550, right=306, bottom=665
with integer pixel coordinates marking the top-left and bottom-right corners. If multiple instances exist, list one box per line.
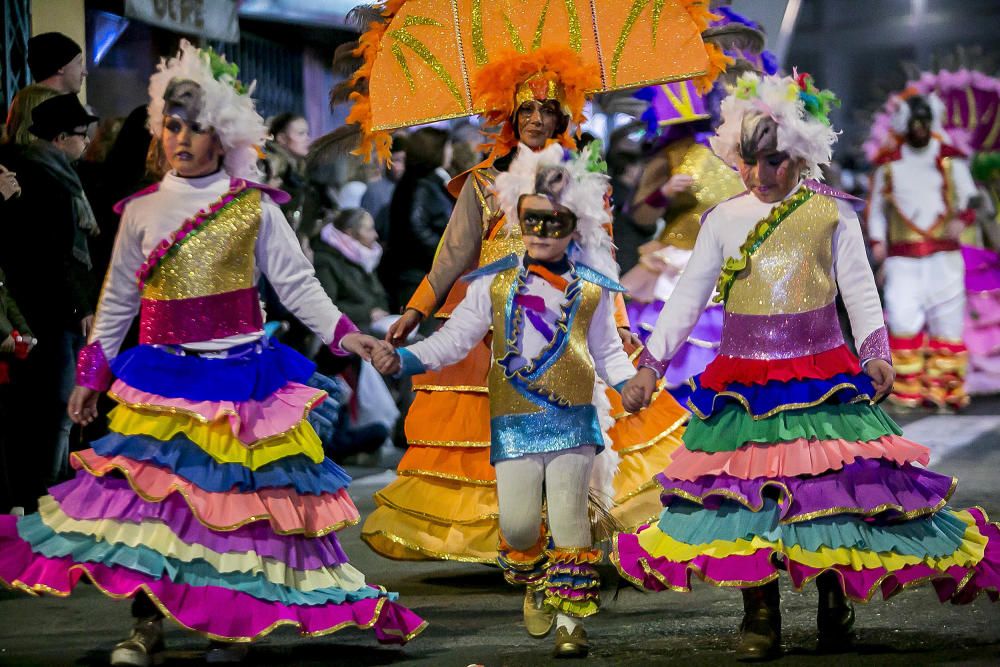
left=622, top=7, right=777, bottom=403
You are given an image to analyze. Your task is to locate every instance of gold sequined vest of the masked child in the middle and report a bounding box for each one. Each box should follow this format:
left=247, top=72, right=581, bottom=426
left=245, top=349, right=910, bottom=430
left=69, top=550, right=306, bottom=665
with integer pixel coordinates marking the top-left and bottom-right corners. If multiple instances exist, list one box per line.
left=488, top=267, right=601, bottom=417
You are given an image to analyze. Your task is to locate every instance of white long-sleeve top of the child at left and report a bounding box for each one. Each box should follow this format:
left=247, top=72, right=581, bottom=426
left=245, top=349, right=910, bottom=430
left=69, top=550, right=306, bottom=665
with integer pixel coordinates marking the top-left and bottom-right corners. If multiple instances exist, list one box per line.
left=88, top=171, right=352, bottom=360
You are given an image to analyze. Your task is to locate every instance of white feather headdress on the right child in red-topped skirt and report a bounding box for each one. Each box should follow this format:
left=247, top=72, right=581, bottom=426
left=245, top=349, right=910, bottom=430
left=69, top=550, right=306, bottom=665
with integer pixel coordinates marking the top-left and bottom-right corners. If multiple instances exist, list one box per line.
left=709, top=72, right=840, bottom=179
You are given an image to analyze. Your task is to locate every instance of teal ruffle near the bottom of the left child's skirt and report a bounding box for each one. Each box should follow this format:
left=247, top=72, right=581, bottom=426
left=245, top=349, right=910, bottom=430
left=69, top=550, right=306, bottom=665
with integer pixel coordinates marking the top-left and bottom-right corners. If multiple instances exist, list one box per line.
left=17, top=514, right=396, bottom=605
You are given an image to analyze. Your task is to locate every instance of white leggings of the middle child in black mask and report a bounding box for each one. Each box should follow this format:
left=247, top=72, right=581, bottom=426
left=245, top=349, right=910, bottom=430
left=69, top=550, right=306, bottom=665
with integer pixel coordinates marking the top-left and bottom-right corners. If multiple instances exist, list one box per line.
left=495, top=445, right=596, bottom=551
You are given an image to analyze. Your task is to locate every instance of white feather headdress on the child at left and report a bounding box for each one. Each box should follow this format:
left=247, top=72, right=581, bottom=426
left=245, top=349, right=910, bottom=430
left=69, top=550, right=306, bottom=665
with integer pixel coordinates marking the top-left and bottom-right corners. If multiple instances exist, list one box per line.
left=148, top=39, right=267, bottom=179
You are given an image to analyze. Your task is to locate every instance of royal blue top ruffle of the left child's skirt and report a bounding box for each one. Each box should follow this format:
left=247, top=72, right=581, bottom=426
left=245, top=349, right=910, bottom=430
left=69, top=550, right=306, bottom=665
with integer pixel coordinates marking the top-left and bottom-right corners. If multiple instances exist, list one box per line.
left=111, top=341, right=316, bottom=401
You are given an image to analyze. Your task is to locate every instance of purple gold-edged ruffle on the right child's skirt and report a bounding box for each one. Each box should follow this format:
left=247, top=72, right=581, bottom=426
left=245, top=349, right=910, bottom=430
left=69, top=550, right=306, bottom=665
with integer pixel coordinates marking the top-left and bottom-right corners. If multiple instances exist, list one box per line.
left=656, top=459, right=957, bottom=522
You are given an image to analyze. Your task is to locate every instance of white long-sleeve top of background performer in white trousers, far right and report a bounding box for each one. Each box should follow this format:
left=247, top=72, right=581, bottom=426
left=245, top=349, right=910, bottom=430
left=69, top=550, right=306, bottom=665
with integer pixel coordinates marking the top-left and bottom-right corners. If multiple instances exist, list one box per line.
left=868, top=139, right=977, bottom=243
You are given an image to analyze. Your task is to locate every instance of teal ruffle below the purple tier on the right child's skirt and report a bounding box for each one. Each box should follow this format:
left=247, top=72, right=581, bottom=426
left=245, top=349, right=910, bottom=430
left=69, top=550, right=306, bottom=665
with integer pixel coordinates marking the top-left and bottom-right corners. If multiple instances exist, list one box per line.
left=658, top=498, right=967, bottom=558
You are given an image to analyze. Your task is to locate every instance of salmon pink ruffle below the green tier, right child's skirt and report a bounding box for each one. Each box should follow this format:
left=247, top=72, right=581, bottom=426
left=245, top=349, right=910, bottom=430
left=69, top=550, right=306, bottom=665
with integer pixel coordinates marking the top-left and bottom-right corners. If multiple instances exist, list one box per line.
left=663, top=435, right=930, bottom=481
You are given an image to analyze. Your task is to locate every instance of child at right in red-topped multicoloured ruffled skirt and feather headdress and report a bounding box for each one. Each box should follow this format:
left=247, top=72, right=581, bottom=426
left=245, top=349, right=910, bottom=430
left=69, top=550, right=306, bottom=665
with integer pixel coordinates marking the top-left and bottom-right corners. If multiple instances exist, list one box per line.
left=613, top=75, right=1000, bottom=659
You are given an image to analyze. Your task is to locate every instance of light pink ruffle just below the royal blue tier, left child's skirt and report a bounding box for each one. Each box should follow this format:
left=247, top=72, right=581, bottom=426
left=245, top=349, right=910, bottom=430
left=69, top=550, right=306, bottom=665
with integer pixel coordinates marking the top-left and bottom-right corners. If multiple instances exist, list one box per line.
left=111, top=380, right=326, bottom=445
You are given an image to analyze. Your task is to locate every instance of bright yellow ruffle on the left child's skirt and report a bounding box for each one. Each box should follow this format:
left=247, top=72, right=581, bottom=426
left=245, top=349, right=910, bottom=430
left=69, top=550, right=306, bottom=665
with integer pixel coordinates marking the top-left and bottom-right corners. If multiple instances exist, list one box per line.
left=109, top=405, right=323, bottom=470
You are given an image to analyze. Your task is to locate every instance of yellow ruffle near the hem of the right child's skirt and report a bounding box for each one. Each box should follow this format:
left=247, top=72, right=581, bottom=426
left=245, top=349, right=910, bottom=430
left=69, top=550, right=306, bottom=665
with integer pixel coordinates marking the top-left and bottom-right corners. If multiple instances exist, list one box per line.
left=638, top=510, right=988, bottom=572
